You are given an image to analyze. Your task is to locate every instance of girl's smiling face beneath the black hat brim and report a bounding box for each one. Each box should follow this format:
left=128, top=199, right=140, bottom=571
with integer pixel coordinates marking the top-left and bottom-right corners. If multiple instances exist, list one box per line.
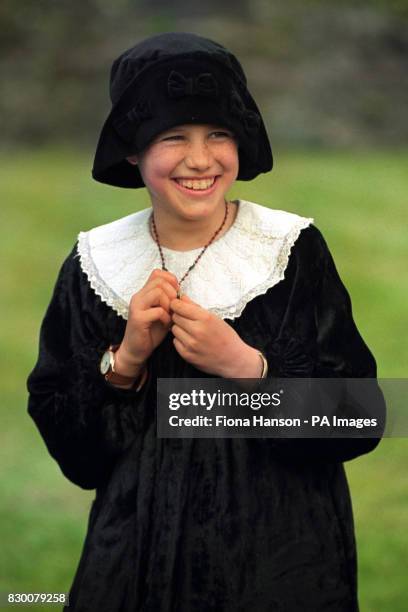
left=128, top=125, right=238, bottom=220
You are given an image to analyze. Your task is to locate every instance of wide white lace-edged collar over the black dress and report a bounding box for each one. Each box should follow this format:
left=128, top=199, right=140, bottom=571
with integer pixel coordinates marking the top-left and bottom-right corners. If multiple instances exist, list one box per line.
left=78, top=200, right=313, bottom=319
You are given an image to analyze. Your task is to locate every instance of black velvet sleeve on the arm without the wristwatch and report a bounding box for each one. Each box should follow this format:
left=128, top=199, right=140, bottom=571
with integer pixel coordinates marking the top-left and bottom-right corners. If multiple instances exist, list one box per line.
left=265, top=226, right=385, bottom=462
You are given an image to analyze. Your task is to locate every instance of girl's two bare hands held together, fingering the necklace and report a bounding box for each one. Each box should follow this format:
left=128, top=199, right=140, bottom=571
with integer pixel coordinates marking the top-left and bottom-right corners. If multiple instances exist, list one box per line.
left=117, top=270, right=262, bottom=378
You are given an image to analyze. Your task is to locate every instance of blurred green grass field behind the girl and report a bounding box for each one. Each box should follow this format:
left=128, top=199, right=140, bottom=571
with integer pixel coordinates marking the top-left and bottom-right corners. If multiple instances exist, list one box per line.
left=0, top=149, right=408, bottom=612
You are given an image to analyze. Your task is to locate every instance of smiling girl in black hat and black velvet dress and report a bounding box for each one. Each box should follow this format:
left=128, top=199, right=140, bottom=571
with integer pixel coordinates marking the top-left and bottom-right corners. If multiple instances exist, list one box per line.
left=28, top=34, right=384, bottom=612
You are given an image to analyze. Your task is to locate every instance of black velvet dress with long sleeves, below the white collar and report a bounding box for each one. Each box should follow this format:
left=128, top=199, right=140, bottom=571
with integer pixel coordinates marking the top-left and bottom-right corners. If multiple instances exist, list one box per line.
left=28, top=226, right=384, bottom=612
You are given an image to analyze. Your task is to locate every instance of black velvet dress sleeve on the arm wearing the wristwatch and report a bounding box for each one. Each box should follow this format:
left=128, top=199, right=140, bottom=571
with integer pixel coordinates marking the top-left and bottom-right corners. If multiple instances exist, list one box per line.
left=27, top=247, right=150, bottom=489
